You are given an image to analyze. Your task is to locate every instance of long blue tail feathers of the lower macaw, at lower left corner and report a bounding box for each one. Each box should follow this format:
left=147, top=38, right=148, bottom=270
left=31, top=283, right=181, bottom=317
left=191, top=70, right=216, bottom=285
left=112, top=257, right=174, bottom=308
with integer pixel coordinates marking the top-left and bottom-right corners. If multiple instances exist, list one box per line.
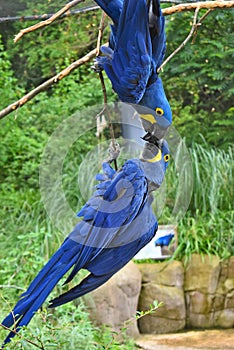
left=2, top=238, right=81, bottom=344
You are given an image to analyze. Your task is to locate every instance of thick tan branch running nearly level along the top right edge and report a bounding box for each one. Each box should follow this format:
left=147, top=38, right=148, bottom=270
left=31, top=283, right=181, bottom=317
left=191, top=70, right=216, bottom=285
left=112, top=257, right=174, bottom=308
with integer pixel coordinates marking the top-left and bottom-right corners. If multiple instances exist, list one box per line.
left=162, top=0, right=234, bottom=16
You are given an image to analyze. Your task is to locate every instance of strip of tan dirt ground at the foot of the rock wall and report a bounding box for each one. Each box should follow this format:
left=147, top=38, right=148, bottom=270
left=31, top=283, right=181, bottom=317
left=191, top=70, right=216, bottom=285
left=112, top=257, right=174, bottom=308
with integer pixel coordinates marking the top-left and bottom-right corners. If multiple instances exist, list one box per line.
left=136, top=328, right=234, bottom=350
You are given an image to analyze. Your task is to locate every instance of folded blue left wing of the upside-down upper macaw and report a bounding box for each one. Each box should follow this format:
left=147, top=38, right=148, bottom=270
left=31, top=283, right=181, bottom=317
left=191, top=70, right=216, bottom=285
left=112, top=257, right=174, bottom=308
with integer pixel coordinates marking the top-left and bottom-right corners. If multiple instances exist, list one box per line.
left=98, top=0, right=152, bottom=103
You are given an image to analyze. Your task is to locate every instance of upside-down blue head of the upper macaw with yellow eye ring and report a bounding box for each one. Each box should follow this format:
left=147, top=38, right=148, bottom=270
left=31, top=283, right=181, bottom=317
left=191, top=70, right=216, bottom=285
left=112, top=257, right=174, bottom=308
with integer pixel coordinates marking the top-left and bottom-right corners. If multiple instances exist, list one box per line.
left=137, top=77, right=172, bottom=139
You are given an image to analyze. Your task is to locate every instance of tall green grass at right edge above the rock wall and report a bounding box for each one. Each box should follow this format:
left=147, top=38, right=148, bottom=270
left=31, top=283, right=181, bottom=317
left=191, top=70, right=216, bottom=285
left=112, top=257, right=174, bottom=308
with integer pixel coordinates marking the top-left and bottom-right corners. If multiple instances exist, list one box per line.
left=167, top=144, right=234, bottom=259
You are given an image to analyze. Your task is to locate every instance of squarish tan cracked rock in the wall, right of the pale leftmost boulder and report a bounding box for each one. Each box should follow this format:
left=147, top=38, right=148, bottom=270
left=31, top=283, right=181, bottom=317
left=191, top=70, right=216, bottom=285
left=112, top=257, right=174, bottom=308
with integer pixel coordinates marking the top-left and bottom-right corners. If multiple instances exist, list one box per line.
left=138, top=261, right=185, bottom=334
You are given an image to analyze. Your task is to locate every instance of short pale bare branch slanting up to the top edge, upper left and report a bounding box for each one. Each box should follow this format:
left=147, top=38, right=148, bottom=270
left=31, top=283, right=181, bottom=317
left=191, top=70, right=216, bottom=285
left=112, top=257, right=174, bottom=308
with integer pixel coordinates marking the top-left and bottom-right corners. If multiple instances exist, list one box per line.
left=14, top=0, right=85, bottom=43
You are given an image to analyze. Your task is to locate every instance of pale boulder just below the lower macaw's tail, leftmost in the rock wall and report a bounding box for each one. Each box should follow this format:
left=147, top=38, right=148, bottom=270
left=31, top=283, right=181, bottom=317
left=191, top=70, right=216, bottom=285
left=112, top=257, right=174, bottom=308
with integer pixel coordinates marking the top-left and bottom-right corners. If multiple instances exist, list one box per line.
left=84, top=262, right=141, bottom=337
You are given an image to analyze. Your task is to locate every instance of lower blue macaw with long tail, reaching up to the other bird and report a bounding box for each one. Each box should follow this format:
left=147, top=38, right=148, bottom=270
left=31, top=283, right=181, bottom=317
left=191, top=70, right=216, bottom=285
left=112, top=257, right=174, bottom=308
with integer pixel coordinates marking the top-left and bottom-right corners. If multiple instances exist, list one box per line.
left=2, top=140, right=169, bottom=346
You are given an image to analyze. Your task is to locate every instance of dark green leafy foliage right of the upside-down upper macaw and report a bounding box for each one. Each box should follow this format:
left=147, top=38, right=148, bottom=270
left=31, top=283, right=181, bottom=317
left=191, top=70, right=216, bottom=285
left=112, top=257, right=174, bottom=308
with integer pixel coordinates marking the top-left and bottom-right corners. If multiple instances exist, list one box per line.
left=162, top=10, right=234, bottom=148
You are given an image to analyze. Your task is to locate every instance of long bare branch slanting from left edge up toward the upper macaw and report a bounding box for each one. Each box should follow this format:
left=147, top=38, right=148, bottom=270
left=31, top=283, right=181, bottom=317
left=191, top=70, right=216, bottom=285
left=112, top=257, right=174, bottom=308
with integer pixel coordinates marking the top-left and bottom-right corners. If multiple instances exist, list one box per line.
left=0, top=49, right=100, bottom=119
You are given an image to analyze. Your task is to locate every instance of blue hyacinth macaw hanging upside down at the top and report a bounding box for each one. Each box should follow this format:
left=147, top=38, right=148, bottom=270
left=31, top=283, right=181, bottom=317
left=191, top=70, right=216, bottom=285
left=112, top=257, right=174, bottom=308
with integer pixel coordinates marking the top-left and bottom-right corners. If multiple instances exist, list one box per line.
left=95, top=0, right=172, bottom=139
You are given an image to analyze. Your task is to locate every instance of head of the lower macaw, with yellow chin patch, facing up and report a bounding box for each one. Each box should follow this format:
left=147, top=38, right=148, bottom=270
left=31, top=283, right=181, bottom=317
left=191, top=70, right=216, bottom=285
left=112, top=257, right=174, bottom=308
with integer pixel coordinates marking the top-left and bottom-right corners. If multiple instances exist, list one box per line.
left=141, top=140, right=170, bottom=190
